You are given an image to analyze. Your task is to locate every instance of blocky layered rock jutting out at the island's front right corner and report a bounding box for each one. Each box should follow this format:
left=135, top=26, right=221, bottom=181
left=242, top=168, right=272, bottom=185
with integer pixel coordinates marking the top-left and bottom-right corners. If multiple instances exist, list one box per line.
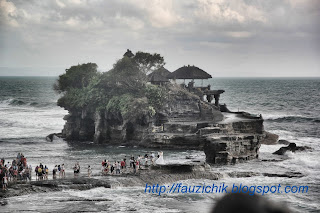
left=204, top=118, right=265, bottom=164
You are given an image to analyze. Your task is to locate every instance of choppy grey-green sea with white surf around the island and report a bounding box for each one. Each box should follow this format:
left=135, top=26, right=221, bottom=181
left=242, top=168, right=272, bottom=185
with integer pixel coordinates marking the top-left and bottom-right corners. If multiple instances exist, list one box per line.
left=0, top=77, right=320, bottom=212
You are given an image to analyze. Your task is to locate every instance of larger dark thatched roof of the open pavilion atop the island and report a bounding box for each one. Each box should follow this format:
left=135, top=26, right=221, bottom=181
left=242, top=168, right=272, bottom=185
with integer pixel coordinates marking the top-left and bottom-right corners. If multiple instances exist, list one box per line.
left=167, top=65, right=212, bottom=79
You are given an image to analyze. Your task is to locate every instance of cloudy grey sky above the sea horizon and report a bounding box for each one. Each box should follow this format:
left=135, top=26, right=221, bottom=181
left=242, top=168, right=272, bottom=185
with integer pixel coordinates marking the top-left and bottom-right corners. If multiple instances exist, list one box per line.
left=0, top=0, right=320, bottom=77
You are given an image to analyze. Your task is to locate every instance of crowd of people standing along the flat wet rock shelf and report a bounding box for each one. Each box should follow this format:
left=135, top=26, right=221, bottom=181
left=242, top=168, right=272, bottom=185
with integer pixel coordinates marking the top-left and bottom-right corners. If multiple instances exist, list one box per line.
left=0, top=152, right=164, bottom=190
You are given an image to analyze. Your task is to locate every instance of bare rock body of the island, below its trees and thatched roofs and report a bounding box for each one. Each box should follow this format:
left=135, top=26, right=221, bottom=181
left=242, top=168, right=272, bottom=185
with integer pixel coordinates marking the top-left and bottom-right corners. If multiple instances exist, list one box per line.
left=62, top=84, right=264, bottom=164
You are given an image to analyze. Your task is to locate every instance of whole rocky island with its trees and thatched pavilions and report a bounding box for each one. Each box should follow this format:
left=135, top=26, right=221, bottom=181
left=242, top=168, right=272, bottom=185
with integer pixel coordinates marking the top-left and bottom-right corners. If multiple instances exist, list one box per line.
left=54, top=50, right=266, bottom=164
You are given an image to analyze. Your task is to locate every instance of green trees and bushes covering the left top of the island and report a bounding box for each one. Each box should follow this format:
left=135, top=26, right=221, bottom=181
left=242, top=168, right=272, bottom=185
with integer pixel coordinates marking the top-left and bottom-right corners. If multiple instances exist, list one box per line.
left=54, top=52, right=167, bottom=121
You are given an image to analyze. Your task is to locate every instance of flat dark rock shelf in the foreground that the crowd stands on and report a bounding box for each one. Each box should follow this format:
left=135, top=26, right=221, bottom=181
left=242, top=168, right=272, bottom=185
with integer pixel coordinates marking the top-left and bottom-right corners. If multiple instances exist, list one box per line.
left=0, top=163, right=303, bottom=205
